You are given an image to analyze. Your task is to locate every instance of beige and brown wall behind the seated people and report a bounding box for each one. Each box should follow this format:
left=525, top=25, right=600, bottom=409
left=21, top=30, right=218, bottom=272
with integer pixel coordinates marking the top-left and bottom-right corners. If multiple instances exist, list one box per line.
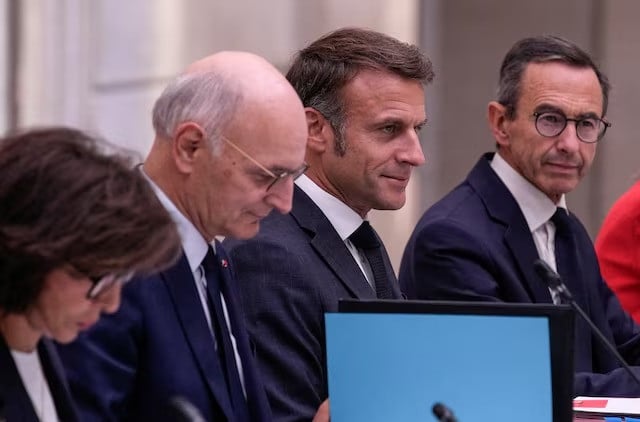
left=0, top=0, right=640, bottom=270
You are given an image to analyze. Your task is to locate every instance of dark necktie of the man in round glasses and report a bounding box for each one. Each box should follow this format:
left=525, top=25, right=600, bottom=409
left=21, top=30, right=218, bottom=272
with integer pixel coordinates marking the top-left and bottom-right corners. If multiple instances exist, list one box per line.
left=551, top=207, right=580, bottom=304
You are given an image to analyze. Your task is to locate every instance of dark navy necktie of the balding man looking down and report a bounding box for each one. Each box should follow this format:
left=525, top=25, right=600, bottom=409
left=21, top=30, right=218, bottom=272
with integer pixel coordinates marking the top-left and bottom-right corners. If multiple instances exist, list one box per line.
left=202, top=247, right=248, bottom=421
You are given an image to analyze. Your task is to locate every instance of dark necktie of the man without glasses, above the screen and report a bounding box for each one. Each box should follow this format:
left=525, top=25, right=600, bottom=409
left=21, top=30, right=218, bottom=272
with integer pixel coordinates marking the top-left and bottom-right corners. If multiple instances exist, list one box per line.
left=349, top=221, right=393, bottom=299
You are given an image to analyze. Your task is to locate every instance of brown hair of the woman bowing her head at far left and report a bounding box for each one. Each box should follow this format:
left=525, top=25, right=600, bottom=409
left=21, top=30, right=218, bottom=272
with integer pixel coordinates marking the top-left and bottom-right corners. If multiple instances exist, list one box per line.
left=0, top=128, right=180, bottom=313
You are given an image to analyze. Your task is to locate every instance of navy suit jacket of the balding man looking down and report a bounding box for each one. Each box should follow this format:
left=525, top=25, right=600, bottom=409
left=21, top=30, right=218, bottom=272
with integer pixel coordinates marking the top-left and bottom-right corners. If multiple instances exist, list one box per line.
left=60, top=245, right=271, bottom=421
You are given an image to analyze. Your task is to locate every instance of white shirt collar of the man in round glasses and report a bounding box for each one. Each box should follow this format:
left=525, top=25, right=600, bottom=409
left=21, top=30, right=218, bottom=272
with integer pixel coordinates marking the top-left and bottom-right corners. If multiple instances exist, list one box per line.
left=491, top=152, right=567, bottom=232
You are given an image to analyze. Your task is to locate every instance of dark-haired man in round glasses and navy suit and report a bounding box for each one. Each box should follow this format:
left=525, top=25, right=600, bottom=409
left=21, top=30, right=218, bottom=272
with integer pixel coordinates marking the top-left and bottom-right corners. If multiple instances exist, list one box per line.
left=399, top=36, right=640, bottom=396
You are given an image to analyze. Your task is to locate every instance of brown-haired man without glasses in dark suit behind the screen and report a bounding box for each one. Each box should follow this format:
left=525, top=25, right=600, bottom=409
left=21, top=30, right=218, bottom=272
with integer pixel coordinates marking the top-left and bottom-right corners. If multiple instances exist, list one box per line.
left=225, top=28, right=433, bottom=421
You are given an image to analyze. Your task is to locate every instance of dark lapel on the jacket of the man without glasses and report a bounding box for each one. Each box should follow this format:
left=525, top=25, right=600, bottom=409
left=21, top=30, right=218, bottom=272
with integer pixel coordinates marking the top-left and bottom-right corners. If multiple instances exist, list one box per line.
left=291, top=186, right=378, bottom=299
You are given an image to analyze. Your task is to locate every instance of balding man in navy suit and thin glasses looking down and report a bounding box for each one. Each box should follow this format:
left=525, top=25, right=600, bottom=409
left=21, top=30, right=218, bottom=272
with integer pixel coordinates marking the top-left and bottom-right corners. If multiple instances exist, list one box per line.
left=61, top=52, right=307, bottom=422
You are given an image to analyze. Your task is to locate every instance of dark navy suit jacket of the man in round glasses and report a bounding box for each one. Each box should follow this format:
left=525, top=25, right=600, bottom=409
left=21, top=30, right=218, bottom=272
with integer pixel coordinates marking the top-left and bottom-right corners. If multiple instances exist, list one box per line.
left=399, top=154, right=640, bottom=396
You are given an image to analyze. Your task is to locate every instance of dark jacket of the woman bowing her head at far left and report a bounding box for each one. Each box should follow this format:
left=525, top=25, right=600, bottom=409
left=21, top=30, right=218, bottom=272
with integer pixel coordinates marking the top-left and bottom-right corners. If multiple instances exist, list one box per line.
left=0, top=336, right=79, bottom=422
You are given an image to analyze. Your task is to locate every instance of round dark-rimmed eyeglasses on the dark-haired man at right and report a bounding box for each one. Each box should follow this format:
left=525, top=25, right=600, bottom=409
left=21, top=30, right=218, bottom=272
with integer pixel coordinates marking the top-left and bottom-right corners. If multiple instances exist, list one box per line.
left=533, top=111, right=611, bottom=144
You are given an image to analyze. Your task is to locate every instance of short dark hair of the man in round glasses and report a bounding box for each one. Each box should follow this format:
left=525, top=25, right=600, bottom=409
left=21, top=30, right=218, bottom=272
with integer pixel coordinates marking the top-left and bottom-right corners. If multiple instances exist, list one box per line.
left=498, top=35, right=610, bottom=119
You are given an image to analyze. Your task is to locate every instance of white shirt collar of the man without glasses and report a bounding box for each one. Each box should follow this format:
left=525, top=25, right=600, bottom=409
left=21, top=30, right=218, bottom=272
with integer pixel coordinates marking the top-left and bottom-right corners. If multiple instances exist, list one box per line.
left=296, top=174, right=364, bottom=241
